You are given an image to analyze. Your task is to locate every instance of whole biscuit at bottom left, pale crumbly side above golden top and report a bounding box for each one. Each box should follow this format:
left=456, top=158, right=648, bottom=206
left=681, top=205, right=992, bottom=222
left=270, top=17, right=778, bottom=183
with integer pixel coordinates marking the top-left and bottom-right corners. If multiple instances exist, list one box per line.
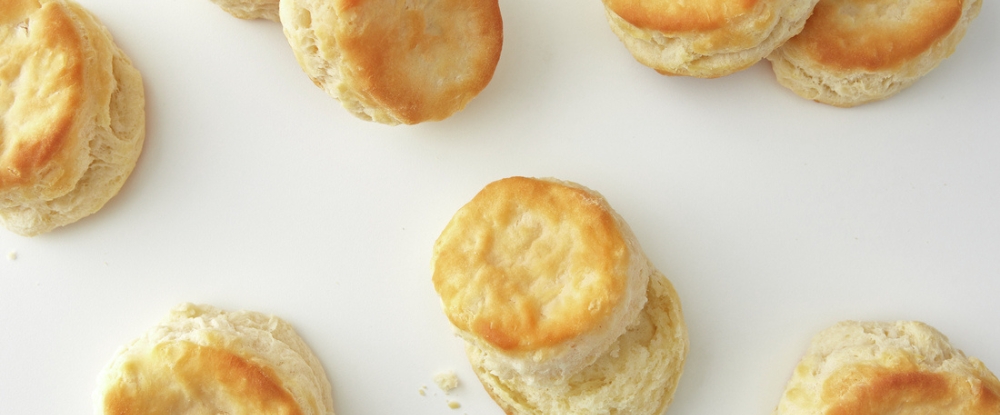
left=95, top=304, right=333, bottom=415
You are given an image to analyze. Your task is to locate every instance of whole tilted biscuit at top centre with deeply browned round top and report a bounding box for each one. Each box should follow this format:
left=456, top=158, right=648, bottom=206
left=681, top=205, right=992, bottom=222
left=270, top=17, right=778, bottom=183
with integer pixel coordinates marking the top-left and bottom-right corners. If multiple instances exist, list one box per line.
left=280, top=0, right=503, bottom=125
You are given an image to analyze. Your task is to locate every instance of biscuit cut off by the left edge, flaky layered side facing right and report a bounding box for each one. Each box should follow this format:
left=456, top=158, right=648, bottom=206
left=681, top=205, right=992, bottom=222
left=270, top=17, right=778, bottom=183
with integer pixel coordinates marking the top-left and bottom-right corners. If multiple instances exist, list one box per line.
left=0, top=0, right=145, bottom=236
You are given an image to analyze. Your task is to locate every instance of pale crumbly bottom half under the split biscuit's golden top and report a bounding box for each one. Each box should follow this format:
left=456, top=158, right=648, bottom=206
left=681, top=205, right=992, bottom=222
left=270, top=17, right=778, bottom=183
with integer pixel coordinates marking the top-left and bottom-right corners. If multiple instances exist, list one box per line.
left=466, top=272, right=688, bottom=415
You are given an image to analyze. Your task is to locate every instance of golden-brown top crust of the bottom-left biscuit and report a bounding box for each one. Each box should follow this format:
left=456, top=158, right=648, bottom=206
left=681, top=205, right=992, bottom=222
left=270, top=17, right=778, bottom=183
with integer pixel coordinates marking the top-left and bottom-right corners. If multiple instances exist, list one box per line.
left=103, top=341, right=302, bottom=415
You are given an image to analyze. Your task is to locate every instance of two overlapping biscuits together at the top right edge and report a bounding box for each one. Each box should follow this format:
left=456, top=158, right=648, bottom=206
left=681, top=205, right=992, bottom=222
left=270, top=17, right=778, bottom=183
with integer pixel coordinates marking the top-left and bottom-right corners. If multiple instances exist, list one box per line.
left=604, top=0, right=982, bottom=107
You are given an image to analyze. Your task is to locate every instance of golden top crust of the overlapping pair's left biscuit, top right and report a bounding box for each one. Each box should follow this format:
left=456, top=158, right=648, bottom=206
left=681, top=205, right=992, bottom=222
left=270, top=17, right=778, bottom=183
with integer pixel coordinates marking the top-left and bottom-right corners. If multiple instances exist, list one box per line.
left=604, top=0, right=771, bottom=33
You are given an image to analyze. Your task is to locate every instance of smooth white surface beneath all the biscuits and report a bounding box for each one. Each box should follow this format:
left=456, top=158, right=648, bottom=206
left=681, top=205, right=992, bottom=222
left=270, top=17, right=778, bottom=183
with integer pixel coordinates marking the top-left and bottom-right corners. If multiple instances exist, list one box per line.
left=0, top=0, right=1000, bottom=415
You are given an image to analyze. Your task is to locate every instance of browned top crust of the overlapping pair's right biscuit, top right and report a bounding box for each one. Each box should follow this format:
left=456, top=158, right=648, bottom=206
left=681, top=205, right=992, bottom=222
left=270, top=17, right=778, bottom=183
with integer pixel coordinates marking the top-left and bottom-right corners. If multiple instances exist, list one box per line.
left=785, top=0, right=963, bottom=71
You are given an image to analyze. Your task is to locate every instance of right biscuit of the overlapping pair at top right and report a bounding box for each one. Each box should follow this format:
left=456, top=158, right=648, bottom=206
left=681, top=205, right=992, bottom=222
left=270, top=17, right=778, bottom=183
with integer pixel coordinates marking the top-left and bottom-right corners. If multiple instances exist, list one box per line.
left=768, top=0, right=982, bottom=107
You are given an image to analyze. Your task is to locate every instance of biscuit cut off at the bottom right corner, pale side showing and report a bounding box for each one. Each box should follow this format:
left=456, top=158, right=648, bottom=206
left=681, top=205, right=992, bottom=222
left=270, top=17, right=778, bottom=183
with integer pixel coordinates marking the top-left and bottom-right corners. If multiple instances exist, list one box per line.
left=774, top=321, right=1000, bottom=415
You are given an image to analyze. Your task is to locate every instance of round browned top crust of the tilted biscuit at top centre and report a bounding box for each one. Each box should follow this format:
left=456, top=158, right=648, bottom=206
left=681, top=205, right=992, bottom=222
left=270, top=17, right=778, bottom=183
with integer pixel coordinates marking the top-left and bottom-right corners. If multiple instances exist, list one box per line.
left=336, top=0, right=503, bottom=124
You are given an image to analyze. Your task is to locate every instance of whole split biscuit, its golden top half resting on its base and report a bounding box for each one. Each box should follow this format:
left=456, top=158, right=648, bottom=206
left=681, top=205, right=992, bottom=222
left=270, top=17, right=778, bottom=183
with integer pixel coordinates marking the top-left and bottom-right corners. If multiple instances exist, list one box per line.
left=432, top=177, right=687, bottom=414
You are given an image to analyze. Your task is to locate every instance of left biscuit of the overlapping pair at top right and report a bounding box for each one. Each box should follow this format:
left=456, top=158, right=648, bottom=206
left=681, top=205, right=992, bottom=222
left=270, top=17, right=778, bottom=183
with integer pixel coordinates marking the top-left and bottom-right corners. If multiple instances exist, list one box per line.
left=603, top=0, right=817, bottom=78
